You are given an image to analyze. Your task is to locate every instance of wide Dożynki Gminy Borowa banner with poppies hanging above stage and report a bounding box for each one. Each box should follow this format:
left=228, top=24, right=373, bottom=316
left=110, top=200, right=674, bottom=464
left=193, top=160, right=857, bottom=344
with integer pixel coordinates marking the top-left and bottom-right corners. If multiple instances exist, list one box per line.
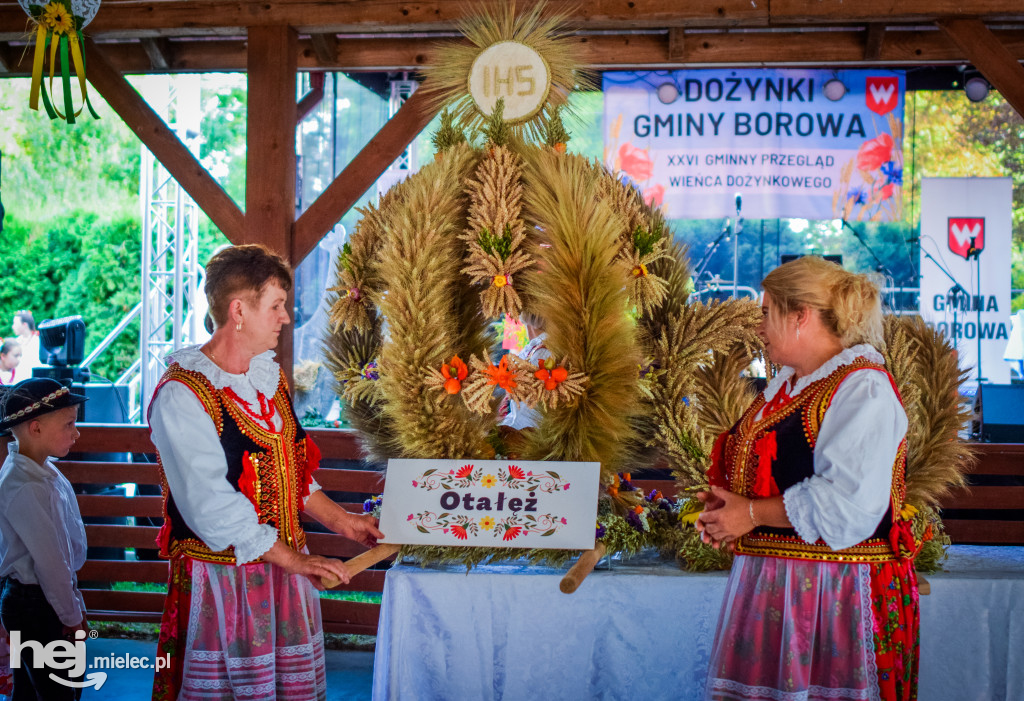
left=602, top=69, right=904, bottom=221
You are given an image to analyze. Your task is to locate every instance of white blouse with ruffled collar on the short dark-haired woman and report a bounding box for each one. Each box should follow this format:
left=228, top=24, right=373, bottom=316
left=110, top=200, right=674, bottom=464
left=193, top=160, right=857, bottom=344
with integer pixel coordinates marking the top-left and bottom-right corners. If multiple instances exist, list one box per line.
left=150, top=346, right=319, bottom=565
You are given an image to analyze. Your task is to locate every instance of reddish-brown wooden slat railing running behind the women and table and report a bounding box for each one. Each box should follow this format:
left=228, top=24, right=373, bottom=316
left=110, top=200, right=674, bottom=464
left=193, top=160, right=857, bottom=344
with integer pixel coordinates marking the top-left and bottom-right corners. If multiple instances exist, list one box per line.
left=0, top=424, right=1024, bottom=634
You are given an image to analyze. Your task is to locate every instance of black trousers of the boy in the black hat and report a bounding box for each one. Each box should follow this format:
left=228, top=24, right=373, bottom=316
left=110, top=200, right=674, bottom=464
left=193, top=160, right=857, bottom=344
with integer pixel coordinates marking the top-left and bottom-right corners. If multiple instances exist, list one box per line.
left=0, top=577, right=83, bottom=701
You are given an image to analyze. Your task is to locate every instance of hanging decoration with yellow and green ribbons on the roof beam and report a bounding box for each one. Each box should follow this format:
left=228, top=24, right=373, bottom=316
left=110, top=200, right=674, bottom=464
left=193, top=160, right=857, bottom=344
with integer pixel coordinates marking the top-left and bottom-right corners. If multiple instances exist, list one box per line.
left=29, top=0, right=99, bottom=124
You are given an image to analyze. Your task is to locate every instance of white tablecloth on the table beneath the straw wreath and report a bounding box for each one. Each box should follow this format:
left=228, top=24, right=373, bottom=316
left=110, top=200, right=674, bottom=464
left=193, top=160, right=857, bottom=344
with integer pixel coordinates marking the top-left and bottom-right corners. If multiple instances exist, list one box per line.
left=374, top=545, right=1024, bottom=701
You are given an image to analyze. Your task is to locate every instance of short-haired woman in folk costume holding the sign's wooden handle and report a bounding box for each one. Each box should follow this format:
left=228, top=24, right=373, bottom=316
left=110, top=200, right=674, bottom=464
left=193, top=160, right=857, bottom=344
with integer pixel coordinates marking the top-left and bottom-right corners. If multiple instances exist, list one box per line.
left=150, top=246, right=382, bottom=700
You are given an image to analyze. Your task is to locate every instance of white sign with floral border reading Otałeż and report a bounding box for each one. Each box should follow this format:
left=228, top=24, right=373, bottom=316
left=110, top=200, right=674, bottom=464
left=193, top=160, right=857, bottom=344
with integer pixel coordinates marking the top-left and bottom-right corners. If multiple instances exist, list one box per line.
left=380, top=459, right=601, bottom=550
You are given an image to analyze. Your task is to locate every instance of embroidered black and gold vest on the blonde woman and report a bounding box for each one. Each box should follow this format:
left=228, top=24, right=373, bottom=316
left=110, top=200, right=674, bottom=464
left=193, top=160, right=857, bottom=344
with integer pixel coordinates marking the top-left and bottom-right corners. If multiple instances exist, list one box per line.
left=716, top=358, right=906, bottom=562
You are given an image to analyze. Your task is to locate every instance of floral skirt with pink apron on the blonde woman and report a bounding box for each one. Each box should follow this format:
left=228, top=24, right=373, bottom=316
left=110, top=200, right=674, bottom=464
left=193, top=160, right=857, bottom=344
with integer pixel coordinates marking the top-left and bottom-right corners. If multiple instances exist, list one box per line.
left=706, top=556, right=920, bottom=701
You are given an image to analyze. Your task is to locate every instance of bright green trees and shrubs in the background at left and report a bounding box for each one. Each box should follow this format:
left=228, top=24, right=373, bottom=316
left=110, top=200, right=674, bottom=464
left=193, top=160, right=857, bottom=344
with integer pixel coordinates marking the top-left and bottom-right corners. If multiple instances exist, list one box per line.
left=0, top=76, right=237, bottom=380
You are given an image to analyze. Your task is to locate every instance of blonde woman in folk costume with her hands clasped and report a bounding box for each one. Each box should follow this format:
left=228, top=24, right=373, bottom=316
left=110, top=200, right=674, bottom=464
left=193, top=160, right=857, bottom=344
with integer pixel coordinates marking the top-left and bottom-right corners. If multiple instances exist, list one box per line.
left=697, top=257, right=919, bottom=700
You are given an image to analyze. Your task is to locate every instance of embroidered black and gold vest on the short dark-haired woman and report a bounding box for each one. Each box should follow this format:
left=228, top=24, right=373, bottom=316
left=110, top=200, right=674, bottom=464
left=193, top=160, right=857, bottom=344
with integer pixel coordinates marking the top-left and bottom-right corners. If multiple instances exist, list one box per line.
left=151, top=363, right=319, bottom=565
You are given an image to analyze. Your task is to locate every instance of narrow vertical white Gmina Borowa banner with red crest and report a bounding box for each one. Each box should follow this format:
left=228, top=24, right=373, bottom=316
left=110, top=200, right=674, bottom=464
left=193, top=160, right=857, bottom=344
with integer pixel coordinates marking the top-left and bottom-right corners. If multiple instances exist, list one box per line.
left=921, top=178, right=1013, bottom=384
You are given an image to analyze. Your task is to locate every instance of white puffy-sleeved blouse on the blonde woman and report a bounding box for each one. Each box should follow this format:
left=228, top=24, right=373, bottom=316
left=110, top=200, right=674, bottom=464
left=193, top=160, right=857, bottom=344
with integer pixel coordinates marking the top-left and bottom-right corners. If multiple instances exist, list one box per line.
left=770, top=344, right=907, bottom=550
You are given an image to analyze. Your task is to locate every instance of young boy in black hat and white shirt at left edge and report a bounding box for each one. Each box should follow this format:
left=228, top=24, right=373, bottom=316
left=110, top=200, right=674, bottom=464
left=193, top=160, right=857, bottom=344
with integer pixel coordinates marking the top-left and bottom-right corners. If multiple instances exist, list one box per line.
left=0, top=378, right=88, bottom=700
